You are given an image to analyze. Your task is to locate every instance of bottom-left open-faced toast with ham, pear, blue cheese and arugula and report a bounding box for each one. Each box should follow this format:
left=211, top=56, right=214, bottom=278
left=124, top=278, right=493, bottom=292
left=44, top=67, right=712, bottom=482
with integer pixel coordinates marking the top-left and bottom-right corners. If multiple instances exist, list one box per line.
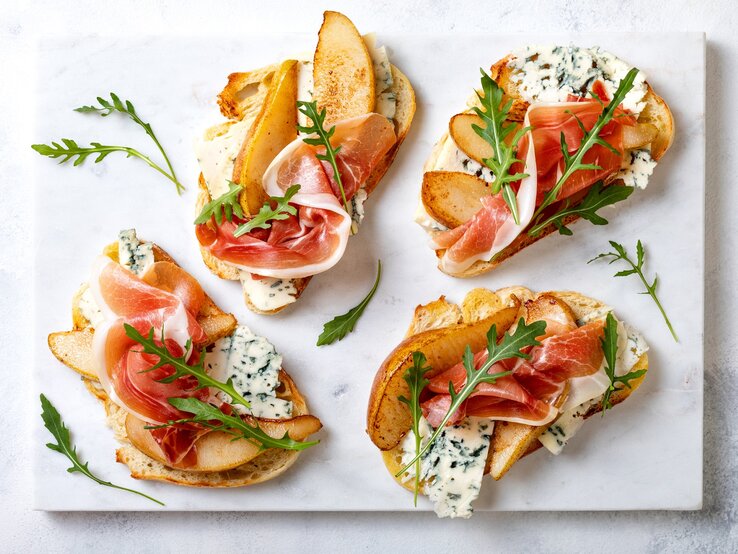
left=49, top=229, right=321, bottom=487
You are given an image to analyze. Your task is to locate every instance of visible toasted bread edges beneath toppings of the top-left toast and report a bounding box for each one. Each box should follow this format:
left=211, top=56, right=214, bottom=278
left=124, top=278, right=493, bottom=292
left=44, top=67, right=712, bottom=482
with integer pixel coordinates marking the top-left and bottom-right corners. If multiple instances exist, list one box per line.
left=196, top=53, right=416, bottom=315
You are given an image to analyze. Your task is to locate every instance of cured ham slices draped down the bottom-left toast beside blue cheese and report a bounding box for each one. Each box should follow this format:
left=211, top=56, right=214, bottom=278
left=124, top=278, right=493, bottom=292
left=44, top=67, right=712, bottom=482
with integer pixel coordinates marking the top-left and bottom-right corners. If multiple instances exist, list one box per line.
left=90, top=256, right=210, bottom=466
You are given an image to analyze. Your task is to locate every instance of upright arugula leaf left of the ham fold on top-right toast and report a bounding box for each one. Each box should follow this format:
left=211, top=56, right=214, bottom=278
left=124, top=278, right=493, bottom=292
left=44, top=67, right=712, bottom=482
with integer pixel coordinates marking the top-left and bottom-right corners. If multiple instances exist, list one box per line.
left=472, top=69, right=530, bottom=224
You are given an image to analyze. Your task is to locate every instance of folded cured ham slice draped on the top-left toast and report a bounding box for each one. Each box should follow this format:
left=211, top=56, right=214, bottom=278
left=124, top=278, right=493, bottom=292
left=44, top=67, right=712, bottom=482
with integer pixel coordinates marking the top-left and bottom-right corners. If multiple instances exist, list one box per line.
left=196, top=114, right=396, bottom=279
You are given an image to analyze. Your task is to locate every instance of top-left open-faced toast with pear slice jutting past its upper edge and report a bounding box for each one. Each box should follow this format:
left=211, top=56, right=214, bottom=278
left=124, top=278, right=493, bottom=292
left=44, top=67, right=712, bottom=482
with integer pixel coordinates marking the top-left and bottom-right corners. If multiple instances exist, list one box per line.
left=195, top=12, right=415, bottom=314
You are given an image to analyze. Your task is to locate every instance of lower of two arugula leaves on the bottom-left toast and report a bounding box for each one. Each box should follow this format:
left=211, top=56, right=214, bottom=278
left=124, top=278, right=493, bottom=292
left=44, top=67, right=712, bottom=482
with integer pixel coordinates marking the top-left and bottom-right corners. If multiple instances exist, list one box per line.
left=146, top=398, right=320, bottom=450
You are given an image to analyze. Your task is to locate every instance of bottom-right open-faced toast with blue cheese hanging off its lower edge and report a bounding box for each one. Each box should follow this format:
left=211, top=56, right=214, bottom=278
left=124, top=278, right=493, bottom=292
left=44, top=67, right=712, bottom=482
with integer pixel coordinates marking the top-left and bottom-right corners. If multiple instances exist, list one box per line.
left=367, top=287, right=648, bottom=517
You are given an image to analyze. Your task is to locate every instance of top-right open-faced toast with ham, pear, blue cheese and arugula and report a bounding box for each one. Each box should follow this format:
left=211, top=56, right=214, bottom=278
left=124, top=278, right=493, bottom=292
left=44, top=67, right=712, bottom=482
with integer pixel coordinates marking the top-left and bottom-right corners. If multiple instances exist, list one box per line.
left=416, top=46, right=674, bottom=277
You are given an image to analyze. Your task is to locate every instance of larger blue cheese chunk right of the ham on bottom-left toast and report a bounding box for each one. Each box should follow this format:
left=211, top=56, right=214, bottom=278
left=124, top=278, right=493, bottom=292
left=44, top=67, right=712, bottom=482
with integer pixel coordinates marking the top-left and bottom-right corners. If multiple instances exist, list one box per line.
left=205, top=325, right=292, bottom=419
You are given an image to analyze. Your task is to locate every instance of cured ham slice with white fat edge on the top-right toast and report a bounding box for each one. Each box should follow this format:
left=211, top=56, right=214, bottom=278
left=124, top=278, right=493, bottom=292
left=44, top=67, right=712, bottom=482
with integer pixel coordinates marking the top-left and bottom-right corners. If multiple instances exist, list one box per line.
left=432, top=81, right=635, bottom=273
